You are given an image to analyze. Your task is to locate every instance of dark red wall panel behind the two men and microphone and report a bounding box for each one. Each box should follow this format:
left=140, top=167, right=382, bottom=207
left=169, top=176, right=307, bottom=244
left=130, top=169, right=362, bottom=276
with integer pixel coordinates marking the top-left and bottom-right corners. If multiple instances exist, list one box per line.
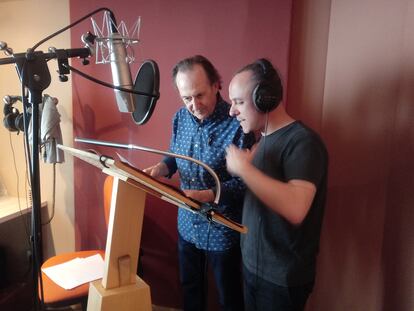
left=70, top=0, right=291, bottom=306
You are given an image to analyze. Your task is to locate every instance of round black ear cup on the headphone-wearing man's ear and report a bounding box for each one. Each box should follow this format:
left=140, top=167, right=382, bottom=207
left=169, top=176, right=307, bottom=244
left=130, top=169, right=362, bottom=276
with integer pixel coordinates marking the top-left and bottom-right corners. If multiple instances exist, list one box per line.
left=253, top=82, right=281, bottom=113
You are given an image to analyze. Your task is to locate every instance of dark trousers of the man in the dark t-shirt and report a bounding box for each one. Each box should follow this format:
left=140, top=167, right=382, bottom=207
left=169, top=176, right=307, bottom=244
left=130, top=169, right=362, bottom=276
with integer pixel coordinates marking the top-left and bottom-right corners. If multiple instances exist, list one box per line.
left=243, top=265, right=313, bottom=311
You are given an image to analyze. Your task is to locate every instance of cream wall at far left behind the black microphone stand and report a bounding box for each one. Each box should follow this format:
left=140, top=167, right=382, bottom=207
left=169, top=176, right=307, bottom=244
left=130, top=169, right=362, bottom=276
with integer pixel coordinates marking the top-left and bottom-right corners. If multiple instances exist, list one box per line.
left=0, top=0, right=75, bottom=258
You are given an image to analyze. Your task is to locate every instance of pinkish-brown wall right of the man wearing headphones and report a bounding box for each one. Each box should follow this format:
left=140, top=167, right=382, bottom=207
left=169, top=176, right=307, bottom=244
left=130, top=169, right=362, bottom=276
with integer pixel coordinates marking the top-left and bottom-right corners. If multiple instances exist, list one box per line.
left=288, top=0, right=414, bottom=311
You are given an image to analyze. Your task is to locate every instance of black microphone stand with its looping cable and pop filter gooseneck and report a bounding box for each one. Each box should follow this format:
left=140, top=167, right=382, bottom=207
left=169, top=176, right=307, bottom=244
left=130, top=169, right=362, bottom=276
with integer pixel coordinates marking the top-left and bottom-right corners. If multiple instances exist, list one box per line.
left=0, top=7, right=159, bottom=311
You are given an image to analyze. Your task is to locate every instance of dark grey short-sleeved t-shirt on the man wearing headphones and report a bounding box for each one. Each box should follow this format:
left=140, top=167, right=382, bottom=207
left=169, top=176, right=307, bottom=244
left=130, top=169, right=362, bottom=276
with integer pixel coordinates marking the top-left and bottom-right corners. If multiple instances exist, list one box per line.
left=241, top=121, right=328, bottom=286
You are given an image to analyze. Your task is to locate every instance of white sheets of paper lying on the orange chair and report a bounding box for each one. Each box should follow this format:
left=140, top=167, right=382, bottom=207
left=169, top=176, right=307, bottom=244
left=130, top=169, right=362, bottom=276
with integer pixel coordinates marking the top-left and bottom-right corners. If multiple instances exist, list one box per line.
left=42, top=254, right=104, bottom=289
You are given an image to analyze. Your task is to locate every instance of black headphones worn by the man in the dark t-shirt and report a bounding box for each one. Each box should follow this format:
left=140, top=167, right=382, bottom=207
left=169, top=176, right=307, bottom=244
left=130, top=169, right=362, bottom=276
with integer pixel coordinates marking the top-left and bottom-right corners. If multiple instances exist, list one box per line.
left=252, top=58, right=283, bottom=113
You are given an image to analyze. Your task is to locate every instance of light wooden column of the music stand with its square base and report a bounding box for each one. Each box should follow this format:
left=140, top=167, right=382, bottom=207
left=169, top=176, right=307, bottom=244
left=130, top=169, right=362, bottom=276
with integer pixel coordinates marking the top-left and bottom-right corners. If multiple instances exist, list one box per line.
left=88, top=177, right=151, bottom=311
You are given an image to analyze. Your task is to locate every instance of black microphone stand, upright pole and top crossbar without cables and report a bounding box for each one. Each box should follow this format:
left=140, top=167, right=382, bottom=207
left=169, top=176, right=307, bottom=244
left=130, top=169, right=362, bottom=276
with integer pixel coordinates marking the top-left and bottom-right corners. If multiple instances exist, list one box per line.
left=0, top=48, right=90, bottom=310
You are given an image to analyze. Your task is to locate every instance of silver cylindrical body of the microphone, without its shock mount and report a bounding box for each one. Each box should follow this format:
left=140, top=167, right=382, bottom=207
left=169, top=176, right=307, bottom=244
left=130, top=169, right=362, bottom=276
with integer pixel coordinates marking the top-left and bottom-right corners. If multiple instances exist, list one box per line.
left=109, top=28, right=135, bottom=112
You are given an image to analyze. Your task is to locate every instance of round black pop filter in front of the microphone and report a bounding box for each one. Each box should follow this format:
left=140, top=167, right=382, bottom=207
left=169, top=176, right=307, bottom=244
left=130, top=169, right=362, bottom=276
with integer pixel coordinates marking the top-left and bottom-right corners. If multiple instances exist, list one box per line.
left=132, top=59, right=160, bottom=125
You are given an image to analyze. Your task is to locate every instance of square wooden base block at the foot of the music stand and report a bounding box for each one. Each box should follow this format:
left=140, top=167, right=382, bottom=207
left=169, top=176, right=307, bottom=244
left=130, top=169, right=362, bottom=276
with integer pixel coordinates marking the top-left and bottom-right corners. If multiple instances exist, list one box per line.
left=88, top=276, right=152, bottom=311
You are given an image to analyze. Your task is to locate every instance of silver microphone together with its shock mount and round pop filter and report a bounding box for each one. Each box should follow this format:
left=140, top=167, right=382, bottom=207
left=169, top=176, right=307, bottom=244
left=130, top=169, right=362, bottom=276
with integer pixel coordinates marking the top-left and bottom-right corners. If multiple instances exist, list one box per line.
left=81, top=10, right=160, bottom=125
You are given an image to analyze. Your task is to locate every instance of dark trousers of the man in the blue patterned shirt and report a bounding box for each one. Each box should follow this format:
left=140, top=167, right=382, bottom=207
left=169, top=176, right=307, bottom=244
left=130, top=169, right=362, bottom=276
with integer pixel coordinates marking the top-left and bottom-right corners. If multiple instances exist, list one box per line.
left=178, top=235, right=243, bottom=311
